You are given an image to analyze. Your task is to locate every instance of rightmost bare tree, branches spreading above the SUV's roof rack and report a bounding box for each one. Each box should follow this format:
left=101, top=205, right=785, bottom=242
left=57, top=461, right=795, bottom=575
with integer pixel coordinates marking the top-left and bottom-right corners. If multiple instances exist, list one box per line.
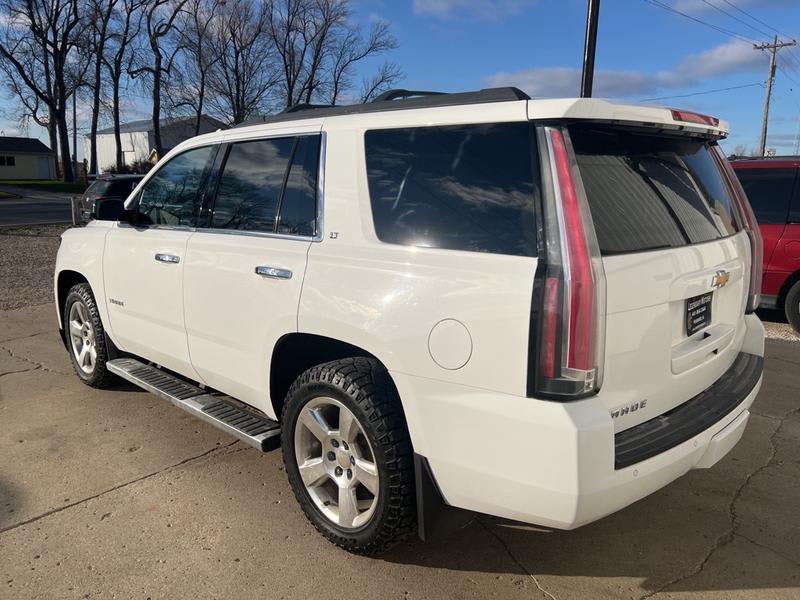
left=268, top=0, right=400, bottom=107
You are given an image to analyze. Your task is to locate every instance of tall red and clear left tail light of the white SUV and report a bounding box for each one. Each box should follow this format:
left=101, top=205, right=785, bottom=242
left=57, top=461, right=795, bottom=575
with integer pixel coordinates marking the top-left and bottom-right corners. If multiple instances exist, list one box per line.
left=529, top=127, right=605, bottom=400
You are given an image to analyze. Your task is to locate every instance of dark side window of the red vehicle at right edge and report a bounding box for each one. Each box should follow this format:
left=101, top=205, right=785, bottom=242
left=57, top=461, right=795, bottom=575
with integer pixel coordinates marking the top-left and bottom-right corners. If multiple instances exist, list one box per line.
left=736, top=169, right=795, bottom=225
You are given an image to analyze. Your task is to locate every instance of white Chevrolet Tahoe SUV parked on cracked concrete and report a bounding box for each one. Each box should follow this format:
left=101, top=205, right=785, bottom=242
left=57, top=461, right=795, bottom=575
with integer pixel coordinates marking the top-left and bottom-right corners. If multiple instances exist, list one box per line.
left=55, top=88, right=764, bottom=554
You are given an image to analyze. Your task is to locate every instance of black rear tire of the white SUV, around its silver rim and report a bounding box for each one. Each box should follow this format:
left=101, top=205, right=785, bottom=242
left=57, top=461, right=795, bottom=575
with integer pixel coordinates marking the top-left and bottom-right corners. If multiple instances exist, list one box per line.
left=281, top=357, right=416, bottom=555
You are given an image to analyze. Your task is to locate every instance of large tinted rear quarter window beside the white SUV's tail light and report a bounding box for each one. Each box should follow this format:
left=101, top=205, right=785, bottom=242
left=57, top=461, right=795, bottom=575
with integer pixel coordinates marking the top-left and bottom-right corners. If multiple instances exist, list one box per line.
left=364, top=123, right=536, bottom=256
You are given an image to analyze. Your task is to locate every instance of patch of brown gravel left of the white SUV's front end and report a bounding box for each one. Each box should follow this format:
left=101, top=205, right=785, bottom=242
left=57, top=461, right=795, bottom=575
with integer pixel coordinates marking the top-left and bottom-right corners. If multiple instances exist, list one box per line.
left=0, top=225, right=67, bottom=310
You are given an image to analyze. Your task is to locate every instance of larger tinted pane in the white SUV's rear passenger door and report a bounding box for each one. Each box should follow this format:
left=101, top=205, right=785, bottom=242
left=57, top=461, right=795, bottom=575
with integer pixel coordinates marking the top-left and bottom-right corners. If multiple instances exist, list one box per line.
left=212, top=138, right=294, bottom=232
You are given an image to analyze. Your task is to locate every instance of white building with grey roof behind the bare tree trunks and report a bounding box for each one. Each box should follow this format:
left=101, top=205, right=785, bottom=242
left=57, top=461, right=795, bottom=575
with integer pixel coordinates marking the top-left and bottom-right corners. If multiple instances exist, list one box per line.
left=83, top=115, right=227, bottom=173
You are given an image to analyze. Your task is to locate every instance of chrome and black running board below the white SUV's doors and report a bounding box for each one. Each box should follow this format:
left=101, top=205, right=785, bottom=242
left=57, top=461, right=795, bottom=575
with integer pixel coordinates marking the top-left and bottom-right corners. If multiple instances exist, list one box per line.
left=106, top=358, right=281, bottom=452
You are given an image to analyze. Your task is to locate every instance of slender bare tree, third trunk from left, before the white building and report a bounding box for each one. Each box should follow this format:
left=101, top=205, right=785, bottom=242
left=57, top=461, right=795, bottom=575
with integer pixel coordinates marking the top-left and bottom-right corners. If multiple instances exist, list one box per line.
left=104, top=0, right=145, bottom=172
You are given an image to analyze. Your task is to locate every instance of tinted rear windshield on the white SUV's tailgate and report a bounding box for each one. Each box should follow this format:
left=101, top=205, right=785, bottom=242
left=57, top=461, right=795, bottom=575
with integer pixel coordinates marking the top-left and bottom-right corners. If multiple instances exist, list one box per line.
left=570, top=125, right=737, bottom=254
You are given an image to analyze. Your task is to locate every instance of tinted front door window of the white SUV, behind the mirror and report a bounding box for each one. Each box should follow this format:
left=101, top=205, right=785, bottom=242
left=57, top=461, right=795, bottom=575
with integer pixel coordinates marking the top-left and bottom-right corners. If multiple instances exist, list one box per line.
left=138, top=146, right=214, bottom=226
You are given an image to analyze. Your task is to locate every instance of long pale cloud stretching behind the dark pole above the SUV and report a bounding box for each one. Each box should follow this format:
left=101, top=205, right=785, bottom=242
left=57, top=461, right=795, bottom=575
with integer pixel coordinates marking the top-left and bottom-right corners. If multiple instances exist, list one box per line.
left=486, top=40, right=767, bottom=97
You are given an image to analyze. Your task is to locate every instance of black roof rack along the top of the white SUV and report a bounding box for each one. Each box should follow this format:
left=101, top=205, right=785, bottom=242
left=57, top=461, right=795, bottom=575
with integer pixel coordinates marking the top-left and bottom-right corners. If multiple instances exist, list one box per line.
left=236, top=87, right=530, bottom=127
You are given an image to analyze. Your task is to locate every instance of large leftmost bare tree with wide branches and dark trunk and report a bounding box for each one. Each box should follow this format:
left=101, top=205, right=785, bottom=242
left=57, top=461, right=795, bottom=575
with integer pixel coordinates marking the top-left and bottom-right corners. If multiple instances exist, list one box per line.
left=0, top=0, right=85, bottom=181
